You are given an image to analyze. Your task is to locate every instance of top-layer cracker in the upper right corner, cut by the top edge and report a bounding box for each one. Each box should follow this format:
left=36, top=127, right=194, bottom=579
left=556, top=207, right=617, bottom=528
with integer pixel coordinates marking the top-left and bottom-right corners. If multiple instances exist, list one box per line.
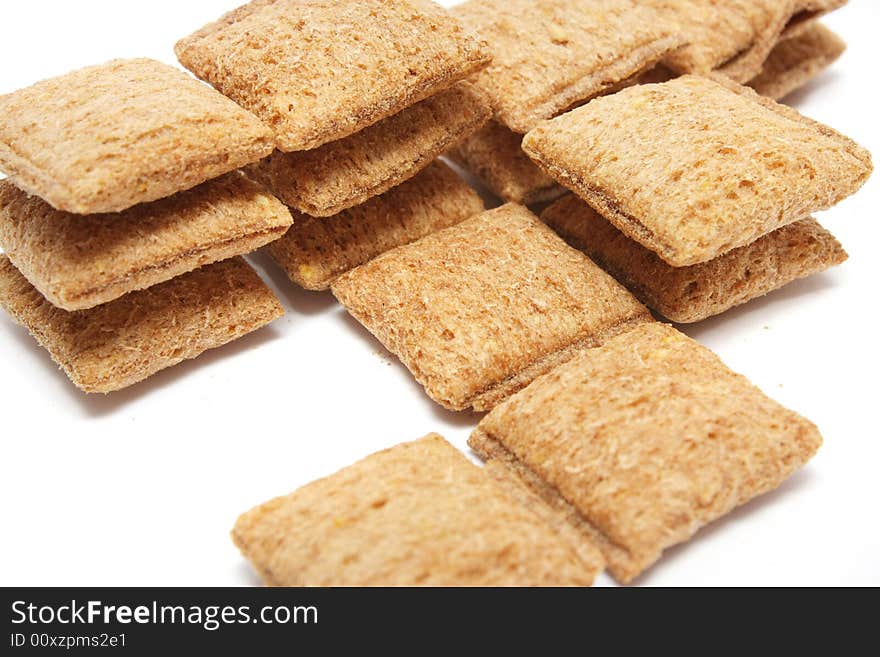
left=648, top=0, right=846, bottom=82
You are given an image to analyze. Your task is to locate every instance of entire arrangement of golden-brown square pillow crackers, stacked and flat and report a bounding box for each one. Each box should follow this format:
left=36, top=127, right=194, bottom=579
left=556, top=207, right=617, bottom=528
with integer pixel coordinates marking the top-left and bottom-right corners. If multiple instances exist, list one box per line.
left=0, top=0, right=872, bottom=586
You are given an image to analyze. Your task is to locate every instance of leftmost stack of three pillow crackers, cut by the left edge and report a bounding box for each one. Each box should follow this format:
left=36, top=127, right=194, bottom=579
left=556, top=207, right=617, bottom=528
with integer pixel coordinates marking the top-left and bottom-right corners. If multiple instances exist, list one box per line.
left=0, top=59, right=293, bottom=393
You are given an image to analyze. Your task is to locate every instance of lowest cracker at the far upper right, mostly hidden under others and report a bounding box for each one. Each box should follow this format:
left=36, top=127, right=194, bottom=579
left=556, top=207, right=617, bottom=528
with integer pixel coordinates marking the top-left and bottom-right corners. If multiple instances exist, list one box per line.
left=749, top=23, right=846, bottom=100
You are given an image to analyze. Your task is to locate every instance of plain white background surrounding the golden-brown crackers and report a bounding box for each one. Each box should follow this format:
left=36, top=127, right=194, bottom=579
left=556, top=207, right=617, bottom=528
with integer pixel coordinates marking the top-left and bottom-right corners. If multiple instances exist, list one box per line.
left=0, top=0, right=880, bottom=585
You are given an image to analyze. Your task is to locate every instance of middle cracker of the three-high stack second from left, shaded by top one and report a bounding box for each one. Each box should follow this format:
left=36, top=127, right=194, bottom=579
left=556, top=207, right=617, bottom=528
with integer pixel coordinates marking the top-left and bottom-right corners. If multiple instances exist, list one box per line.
left=248, top=82, right=492, bottom=217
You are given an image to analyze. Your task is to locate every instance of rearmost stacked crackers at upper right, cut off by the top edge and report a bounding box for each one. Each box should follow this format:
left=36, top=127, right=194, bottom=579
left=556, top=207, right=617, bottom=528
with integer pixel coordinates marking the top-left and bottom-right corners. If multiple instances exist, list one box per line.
left=450, top=0, right=845, bottom=204
